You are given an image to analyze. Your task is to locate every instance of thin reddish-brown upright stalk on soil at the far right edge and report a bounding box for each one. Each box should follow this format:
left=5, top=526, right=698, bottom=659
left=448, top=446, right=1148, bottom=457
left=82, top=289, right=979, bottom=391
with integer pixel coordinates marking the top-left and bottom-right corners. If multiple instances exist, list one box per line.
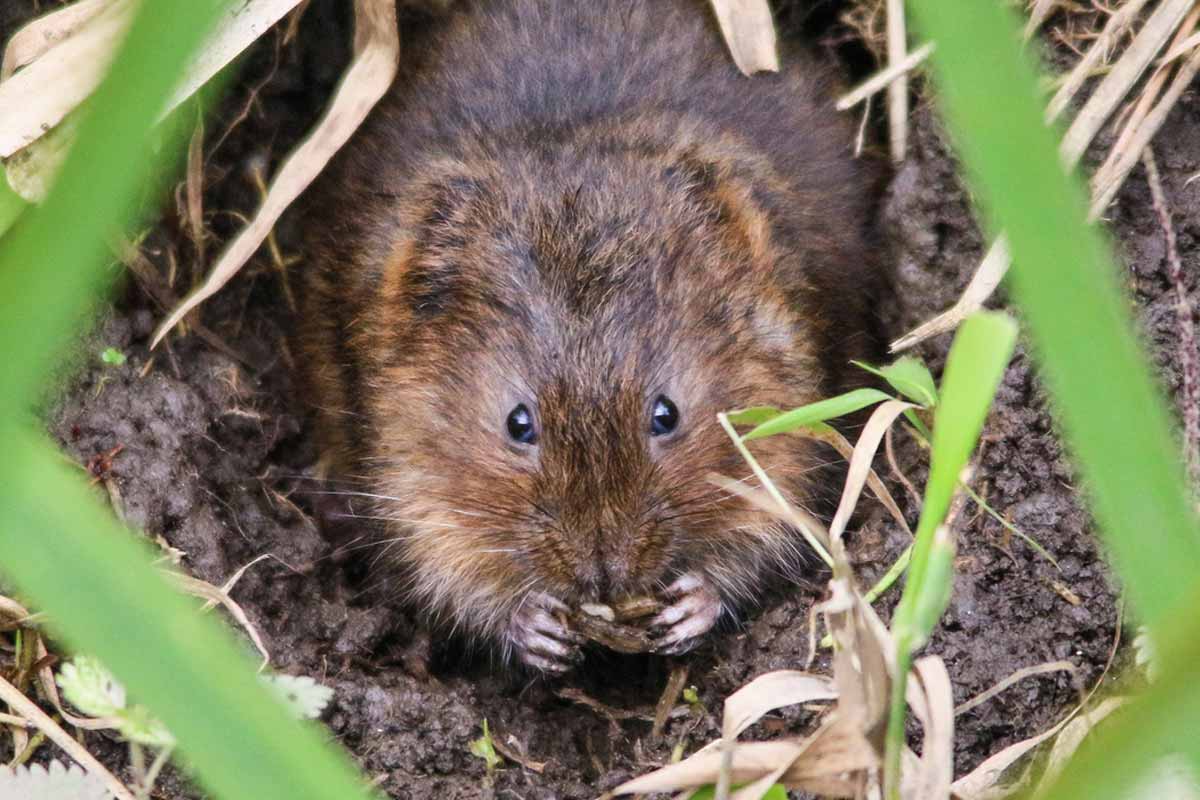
left=1142, top=148, right=1200, bottom=489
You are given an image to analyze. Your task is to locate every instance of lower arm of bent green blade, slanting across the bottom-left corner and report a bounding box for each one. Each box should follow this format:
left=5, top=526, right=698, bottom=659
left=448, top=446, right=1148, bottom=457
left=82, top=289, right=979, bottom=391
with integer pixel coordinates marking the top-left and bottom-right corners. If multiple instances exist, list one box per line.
left=0, top=426, right=366, bottom=800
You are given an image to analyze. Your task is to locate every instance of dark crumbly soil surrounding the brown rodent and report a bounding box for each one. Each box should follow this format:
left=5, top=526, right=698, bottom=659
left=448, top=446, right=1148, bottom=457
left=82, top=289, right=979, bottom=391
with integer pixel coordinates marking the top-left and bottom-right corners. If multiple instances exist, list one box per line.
left=0, top=2, right=1200, bottom=799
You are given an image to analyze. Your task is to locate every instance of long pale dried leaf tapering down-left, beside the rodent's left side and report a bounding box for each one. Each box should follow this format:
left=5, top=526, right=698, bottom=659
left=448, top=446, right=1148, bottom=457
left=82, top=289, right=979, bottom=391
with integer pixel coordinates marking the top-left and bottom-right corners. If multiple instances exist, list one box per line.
left=151, top=0, right=400, bottom=347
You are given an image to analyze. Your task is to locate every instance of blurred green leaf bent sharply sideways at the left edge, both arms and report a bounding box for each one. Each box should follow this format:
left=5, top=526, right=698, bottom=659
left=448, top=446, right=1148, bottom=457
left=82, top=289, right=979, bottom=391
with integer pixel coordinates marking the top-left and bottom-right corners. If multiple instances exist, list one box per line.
left=0, top=0, right=366, bottom=800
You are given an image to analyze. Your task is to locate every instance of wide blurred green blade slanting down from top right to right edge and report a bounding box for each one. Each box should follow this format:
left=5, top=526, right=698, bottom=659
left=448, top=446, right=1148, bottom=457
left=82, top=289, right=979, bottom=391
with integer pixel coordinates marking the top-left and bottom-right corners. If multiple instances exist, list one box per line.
left=910, top=0, right=1200, bottom=628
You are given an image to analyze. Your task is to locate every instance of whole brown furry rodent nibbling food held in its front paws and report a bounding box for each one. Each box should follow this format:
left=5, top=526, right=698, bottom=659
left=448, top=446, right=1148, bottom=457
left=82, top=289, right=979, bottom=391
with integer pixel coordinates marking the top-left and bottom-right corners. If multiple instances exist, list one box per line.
left=298, top=0, right=887, bottom=672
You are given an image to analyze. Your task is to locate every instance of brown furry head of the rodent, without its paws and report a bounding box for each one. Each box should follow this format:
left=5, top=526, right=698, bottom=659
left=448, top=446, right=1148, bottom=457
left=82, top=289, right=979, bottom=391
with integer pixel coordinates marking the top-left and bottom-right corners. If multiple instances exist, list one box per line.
left=359, top=133, right=868, bottom=631
